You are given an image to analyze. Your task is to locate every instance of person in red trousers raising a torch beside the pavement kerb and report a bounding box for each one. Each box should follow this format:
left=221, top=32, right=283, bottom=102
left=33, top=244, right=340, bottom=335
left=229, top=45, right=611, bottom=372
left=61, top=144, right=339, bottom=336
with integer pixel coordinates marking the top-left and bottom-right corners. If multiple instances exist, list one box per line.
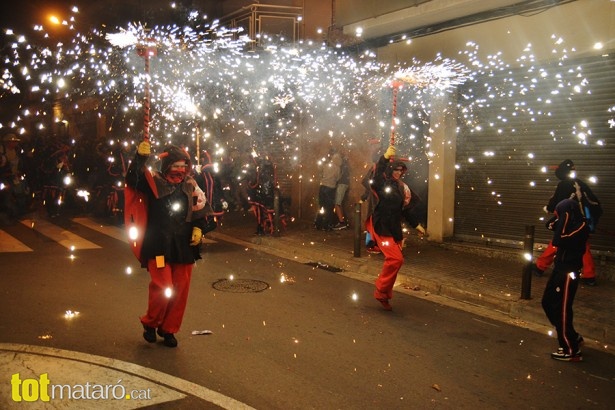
left=365, top=145, right=425, bottom=310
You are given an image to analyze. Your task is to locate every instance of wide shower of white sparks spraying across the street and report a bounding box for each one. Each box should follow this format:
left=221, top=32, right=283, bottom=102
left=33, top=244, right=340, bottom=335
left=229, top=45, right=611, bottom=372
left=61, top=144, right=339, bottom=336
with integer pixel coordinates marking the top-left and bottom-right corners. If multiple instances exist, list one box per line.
left=0, top=4, right=615, bottom=237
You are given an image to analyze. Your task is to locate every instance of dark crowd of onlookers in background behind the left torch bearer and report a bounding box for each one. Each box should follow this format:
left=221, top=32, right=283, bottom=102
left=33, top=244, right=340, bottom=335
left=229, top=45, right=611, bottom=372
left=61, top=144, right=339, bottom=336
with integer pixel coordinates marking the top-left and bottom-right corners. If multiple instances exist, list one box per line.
left=0, top=133, right=284, bottom=226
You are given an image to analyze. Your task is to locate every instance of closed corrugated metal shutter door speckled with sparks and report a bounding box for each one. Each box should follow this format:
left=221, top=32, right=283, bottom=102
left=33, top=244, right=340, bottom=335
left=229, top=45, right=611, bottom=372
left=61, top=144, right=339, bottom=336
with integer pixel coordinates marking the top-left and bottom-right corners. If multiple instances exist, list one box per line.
left=454, top=57, right=615, bottom=251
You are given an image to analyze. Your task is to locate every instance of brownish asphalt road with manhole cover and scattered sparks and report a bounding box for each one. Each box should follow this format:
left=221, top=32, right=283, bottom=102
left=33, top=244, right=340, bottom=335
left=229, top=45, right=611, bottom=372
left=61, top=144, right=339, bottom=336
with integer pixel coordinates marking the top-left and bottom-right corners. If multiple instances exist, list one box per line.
left=0, top=219, right=615, bottom=409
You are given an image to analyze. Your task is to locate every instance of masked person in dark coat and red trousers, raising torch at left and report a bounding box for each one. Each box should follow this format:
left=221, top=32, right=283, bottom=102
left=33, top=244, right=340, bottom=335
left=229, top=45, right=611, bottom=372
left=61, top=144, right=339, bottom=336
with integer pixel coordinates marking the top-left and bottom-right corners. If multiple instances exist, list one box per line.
left=126, top=141, right=210, bottom=347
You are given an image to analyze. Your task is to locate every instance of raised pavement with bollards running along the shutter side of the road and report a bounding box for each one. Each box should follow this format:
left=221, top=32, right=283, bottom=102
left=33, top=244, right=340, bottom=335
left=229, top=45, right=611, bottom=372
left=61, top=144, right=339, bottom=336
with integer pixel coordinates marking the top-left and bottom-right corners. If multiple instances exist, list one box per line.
left=208, top=212, right=615, bottom=353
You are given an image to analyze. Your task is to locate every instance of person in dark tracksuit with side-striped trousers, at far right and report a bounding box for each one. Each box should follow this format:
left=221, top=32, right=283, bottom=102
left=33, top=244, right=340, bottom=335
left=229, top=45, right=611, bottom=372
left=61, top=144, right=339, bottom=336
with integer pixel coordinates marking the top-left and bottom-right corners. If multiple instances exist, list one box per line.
left=542, top=199, right=589, bottom=362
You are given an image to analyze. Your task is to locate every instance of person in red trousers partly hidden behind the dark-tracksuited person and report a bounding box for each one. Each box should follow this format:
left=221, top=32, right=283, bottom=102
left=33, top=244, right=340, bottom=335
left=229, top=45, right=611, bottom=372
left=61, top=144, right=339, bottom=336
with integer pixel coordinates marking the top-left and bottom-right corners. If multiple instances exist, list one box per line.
left=532, top=159, right=602, bottom=286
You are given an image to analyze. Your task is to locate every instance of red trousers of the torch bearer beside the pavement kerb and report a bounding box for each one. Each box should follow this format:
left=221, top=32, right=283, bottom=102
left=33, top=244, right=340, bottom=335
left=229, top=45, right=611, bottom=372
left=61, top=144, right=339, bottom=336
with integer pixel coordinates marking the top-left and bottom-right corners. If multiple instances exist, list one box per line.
left=365, top=218, right=404, bottom=299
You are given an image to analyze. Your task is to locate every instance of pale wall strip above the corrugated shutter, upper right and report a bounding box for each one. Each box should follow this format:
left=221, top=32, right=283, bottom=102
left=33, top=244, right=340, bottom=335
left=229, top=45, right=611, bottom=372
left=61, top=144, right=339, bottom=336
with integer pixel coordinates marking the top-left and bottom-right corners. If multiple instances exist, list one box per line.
left=378, top=0, right=615, bottom=65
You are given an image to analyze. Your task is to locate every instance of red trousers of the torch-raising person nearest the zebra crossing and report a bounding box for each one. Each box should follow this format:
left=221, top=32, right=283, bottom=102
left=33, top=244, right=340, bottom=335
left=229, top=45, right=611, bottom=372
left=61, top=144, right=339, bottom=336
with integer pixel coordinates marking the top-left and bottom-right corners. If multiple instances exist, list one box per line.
left=141, top=259, right=193, bottom=333
